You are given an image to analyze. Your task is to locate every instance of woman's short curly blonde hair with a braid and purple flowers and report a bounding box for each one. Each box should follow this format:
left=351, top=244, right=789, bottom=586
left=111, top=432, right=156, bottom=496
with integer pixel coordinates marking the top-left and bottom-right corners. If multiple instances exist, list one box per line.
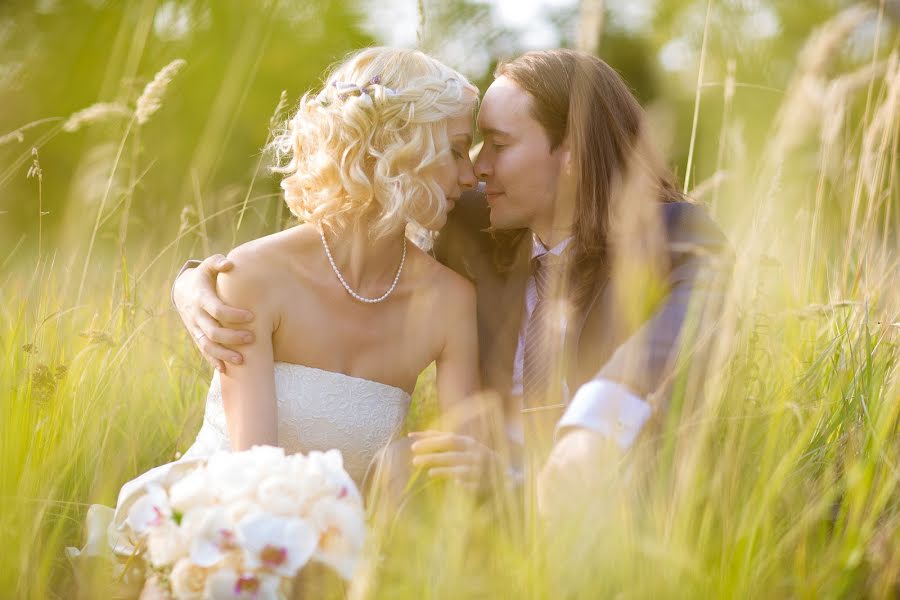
left=272, top=47, right=478, bottom=239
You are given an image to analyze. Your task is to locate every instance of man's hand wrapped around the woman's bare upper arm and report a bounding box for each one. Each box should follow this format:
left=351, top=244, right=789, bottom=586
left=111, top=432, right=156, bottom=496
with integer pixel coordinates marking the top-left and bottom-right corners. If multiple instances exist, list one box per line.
left=172, top=254, right=253, bottom=371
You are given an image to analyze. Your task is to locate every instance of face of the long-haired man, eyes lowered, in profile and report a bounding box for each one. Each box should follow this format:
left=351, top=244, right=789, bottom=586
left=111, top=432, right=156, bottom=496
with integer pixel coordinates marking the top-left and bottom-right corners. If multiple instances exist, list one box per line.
left=475, top=77, right=563, bottom=230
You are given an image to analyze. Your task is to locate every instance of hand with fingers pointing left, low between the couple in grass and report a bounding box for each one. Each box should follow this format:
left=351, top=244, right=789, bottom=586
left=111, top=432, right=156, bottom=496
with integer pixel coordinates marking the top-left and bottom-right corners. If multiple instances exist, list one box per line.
left=409, top=430, right=499, bottom=488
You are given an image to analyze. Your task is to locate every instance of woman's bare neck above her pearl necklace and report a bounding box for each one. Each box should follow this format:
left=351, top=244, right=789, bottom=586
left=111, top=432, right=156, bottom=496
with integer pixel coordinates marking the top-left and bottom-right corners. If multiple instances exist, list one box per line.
left=322, top=227, right=405, bottom=295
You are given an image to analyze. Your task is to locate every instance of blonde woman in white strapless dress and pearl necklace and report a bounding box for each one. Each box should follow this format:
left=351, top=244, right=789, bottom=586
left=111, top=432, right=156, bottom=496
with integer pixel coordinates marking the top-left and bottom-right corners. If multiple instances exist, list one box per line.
left=73, top=48, right=486, bottom=584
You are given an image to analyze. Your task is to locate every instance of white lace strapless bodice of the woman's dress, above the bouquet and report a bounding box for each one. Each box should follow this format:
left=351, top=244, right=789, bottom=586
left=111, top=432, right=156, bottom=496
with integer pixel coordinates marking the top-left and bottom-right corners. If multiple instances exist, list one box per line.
left=184, top=362, right=410, bottom=484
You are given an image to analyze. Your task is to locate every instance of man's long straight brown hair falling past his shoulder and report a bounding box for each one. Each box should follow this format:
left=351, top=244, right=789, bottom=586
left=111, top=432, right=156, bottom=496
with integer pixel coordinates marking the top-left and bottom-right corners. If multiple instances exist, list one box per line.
left=494, top=49, right=684, bottom=310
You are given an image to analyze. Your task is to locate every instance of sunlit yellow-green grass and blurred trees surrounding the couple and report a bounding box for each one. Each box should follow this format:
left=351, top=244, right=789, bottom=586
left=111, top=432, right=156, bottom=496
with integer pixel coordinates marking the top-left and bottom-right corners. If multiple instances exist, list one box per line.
left=0, top=0, right=900, bottom=598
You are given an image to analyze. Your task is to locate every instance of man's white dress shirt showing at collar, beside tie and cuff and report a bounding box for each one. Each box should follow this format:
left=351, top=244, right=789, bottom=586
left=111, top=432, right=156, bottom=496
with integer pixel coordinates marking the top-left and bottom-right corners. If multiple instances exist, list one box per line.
left=510, top=235, right=652, bottom=449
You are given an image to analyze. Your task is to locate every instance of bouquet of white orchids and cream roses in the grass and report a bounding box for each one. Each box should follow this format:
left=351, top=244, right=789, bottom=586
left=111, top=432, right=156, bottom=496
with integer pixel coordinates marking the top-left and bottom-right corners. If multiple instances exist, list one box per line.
left=126, top=446, right=365, bottom=599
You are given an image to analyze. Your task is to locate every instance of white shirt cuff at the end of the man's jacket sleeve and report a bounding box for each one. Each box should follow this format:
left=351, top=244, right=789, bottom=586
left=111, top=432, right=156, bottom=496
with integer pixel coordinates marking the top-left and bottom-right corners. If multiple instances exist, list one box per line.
left=556, top=379, right=653, bottom=450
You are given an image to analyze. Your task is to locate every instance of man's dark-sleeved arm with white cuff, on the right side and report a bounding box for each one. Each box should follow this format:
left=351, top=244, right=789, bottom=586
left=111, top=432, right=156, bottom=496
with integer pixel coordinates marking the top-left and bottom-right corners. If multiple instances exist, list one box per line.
left=557, top=203, right=730, bottom=449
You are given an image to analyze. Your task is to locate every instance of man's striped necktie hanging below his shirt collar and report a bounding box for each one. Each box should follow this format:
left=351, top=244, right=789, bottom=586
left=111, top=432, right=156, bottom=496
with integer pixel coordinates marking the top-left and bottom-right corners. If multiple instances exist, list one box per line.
left=522, top=252, right=563, bottom=408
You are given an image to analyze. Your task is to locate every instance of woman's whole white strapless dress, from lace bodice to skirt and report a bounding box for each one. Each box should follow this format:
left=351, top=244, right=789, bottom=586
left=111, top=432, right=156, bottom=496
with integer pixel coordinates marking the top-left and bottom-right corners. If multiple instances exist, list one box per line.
left=69, top=362, right=411, bottom=558
